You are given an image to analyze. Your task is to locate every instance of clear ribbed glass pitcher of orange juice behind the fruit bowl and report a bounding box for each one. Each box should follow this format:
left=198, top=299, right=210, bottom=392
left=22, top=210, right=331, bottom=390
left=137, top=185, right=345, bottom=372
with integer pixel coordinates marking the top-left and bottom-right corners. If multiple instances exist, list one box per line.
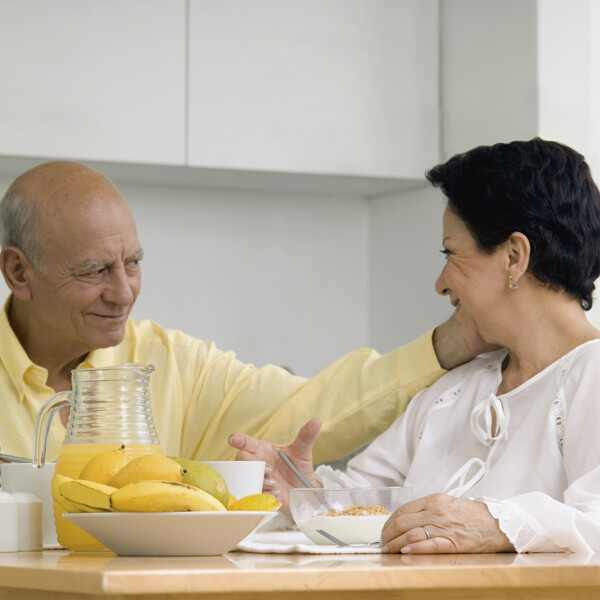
left=33, top=364, right=162, bottom=549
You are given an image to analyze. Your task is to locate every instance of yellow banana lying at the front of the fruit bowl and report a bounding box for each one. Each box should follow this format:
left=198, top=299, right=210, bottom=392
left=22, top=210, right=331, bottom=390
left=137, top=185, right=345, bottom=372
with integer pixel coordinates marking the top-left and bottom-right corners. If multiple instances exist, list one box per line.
left=110, top=481, right=225, bottom=512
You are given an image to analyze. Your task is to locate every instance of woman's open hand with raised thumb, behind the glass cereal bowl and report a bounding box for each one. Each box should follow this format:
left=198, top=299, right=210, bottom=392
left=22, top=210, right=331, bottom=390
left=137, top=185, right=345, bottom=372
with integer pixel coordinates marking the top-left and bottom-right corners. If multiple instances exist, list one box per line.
left=229, top=419, right=323, bottom=513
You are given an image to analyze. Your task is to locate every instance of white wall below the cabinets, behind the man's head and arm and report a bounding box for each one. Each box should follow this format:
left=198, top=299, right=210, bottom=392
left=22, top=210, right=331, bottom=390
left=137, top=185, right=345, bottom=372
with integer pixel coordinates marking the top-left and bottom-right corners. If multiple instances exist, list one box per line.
left=0, top=173, right=369, bottom=375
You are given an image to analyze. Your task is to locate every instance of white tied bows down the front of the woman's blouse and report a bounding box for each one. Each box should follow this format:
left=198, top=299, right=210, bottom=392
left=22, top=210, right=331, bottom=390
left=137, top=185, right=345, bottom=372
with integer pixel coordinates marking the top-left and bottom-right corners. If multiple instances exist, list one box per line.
left=444, top=394, right=509, bottom=498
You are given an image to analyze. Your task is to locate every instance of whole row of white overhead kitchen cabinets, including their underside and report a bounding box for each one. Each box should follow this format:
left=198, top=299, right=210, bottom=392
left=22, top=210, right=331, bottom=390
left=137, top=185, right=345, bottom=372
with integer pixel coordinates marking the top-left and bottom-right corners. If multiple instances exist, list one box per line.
left=0, top=0, right=440, bottom=196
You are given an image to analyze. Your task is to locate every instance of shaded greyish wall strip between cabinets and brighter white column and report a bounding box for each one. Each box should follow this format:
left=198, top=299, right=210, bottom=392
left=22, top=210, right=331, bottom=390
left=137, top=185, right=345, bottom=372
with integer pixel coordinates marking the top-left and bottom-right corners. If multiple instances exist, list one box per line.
left=441, top=0, right=540, bottom=159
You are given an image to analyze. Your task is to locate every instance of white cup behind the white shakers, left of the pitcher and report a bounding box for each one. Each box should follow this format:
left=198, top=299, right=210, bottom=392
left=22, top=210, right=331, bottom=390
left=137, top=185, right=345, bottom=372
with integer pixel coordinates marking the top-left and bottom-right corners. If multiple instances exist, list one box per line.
left=0, top=463, right=58, bottom=546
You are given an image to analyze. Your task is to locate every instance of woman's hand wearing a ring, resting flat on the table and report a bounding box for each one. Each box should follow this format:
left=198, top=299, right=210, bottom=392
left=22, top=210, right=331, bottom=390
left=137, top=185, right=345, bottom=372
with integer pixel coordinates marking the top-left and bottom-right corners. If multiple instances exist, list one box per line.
left=381, top=494, right=514, bottom=554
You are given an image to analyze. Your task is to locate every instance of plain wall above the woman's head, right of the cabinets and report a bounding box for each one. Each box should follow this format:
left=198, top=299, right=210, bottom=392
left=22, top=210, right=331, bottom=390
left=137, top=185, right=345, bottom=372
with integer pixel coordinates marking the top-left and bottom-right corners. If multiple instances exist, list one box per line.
left=441, top=0, right=600, bottom=327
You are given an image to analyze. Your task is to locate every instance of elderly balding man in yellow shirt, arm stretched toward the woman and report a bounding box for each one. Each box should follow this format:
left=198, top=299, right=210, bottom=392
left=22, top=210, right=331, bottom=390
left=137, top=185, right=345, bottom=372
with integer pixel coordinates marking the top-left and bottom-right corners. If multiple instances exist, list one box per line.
left=0, top=161, right=477, bottom=460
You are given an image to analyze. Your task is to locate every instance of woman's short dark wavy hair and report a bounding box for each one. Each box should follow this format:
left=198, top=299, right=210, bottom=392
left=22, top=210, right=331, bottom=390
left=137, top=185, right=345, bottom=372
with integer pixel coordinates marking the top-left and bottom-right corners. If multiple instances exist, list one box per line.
left=425, top=138, right=600, bottom=310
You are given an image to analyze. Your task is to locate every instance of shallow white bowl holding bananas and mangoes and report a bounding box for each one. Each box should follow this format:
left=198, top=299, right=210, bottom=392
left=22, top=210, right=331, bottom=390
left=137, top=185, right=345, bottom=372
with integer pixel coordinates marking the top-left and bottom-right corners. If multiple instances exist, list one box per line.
left=63, top=511, right=277, bottom=556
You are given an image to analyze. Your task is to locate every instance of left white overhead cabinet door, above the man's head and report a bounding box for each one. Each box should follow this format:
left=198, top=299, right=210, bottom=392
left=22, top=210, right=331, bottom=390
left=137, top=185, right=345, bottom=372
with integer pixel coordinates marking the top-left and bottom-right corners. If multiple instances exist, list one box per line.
left=0, top=0, right=186, bottom=165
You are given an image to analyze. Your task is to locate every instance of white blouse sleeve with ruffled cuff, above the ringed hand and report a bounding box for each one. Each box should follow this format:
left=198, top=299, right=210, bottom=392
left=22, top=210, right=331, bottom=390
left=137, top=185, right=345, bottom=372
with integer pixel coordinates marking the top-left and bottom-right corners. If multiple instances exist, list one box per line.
left=478, top=354, right=600, bottom=552
